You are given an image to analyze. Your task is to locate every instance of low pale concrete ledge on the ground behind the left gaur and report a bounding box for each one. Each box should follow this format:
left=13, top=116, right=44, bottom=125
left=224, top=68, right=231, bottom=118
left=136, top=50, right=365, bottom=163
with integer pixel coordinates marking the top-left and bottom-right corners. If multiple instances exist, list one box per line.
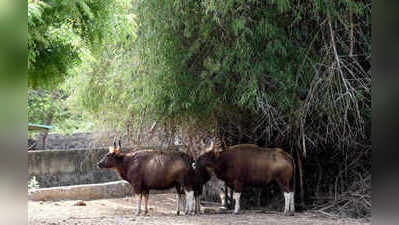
left=28, top=181, right=176, bottom=201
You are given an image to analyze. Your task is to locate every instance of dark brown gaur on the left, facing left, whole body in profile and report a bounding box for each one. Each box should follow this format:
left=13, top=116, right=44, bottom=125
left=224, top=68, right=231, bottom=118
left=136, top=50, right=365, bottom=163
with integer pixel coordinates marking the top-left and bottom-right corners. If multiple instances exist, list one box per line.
left=97, top=140, right=194, bottom=215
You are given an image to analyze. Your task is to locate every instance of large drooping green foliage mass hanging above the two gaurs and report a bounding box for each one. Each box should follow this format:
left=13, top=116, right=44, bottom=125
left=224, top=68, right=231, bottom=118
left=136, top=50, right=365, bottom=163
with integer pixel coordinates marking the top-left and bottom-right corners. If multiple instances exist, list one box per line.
left=68, top=0, right=371, bottom=151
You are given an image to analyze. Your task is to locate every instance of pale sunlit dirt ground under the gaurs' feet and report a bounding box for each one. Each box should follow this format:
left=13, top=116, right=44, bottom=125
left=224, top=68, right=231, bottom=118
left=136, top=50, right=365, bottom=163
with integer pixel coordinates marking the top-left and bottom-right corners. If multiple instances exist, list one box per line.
left=28, top=194, right=370, bottom=225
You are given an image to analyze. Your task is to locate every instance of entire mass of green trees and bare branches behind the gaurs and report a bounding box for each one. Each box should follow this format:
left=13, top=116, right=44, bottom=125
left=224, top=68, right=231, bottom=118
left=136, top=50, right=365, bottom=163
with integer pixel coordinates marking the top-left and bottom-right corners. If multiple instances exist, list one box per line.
left=28, top=0, right=371, bottom=216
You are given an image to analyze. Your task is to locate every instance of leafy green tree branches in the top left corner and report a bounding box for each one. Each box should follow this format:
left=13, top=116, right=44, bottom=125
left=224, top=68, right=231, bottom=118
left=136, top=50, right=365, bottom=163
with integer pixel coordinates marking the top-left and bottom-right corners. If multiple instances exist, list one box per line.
left=28, top=0, right=134, bottom=88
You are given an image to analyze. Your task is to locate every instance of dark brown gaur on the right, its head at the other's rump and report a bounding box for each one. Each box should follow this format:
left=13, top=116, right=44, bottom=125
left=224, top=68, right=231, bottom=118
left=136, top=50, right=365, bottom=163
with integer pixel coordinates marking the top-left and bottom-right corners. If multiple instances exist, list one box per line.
left=196, top=143, right=295, bottom=215
